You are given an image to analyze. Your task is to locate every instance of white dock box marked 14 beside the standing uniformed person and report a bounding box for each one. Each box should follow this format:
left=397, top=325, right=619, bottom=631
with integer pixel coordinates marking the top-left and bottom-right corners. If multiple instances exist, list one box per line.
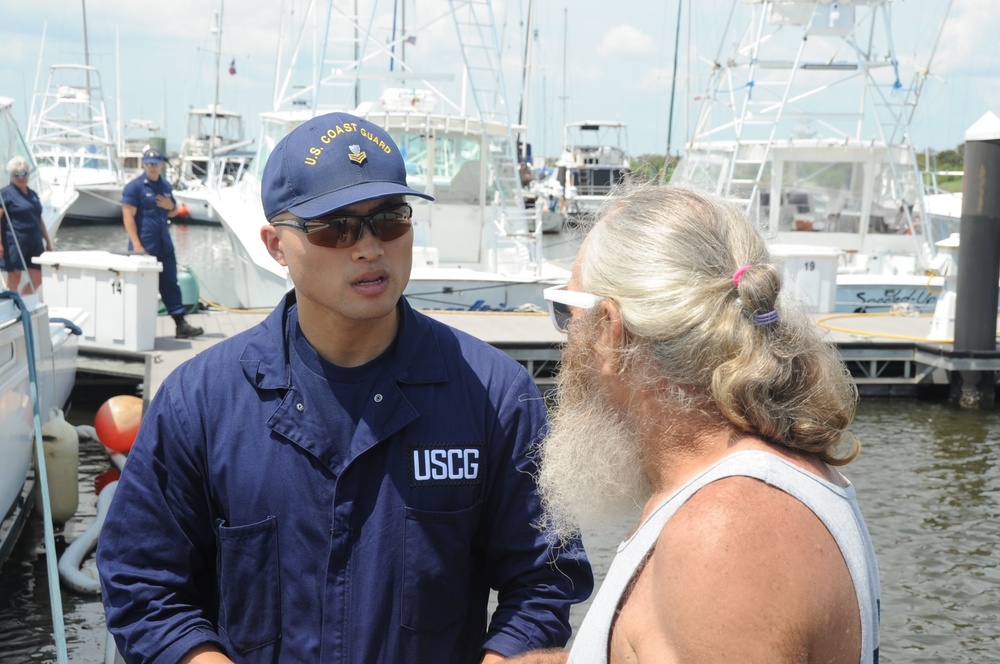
left=34, top=251, right=163, bottom=351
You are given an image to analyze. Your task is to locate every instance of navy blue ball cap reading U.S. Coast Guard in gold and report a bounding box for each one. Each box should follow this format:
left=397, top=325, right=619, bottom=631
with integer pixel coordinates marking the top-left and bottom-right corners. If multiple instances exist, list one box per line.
left=260, top=113, right=434, bottom=221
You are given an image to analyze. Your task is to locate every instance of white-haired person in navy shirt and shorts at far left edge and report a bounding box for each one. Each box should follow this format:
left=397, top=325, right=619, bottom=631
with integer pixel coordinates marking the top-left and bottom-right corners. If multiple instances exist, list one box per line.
left=0, top=157, right=52, bottom=293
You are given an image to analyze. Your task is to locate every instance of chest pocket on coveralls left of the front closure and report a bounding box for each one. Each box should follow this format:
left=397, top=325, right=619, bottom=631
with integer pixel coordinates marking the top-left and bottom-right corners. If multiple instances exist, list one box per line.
left=217, top=516, right=281, bottom=652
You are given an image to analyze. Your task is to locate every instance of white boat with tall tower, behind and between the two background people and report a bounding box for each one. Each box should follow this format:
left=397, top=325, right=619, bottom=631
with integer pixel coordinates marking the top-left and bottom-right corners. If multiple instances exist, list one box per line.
left=28, top=64, right=125, bottom=221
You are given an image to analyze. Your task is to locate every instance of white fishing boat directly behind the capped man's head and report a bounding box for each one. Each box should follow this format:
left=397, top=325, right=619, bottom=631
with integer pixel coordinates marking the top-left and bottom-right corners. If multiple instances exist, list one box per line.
left=210, top=0, right=569, bottom=309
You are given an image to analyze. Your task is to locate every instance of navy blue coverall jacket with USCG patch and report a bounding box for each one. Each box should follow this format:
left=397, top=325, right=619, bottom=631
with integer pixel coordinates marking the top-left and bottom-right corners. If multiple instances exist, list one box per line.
left=98, top=294, right=593, bottom=664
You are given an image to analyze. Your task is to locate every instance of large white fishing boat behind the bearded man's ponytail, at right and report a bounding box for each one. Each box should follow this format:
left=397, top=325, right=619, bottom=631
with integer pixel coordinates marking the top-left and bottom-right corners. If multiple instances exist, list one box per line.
left=671, top=0, right=958, bottom=313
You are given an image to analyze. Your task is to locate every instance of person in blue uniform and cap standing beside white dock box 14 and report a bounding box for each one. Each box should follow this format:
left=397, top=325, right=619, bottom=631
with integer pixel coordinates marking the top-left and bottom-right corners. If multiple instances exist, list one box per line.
left=122, top=149, right=204, bottom=339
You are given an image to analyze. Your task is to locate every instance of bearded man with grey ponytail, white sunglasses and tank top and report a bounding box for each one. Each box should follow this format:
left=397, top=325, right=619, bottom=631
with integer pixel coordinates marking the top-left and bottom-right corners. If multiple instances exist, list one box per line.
left=529, top=186, right=880, bottom=664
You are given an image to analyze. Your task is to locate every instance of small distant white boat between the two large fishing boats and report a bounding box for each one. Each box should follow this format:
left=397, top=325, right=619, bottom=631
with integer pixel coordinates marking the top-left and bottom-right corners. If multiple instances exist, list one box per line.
left=536, top=121, right=632, bottom=230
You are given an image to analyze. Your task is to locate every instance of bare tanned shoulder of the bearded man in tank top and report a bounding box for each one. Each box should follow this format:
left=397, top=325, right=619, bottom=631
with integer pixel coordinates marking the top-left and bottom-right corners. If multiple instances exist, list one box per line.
left=637, top=477, right=860, bottom=662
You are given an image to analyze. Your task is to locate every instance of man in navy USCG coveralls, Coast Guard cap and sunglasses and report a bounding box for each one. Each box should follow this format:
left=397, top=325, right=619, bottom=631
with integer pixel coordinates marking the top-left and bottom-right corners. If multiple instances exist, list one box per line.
left=98, top=113, right=593, bottom=664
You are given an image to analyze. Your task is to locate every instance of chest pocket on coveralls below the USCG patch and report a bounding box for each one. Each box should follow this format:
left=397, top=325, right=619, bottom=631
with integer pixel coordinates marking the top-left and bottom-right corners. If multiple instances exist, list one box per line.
left=402, top=501, right=482, bottom=633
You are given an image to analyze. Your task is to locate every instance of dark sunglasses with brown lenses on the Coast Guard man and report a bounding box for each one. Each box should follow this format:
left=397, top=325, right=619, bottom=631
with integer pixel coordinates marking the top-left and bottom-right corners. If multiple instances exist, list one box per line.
left=271, top=203, right=413, bottom=249
